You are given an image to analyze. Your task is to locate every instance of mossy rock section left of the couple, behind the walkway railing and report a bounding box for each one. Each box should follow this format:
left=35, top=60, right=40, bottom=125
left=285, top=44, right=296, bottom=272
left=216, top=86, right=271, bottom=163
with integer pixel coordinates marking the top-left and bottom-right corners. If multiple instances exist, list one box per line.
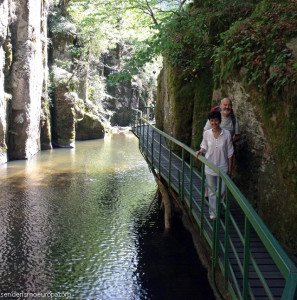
left=155, top=63, right=212, bottom=148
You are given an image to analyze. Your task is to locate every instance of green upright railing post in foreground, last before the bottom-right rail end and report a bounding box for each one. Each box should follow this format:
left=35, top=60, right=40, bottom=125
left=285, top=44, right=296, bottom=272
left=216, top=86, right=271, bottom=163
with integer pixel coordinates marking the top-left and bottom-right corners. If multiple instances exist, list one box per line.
left=242, top=217, right=251, bottom=300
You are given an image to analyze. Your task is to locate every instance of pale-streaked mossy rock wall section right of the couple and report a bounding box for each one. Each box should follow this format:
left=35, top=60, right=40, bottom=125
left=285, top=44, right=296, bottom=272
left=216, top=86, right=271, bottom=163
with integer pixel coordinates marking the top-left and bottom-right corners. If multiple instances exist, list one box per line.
left=224, top=78, right=297, bottom=249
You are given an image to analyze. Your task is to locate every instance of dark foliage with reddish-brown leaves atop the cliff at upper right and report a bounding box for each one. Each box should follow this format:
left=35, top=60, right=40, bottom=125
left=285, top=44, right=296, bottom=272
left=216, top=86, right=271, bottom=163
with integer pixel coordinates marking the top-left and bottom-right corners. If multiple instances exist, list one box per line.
left=214, top=1, right=297, bottom=92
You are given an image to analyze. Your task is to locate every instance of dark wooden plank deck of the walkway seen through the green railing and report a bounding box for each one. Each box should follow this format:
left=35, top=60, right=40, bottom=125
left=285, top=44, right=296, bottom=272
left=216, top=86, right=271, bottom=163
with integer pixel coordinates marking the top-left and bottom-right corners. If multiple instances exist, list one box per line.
left=133, top=126, right=292, bottom=300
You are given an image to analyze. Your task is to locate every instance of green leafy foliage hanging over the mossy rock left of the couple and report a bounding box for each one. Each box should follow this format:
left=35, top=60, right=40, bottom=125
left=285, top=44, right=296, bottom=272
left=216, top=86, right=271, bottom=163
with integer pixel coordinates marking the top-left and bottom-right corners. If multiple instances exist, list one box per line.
left=150, top=1, right=253, bottom=81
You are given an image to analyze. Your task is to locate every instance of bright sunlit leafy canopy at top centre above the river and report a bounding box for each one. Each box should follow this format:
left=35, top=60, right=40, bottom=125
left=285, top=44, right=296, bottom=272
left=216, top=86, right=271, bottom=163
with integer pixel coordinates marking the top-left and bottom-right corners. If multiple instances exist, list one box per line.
left=55, top=0, right=189, bottom=82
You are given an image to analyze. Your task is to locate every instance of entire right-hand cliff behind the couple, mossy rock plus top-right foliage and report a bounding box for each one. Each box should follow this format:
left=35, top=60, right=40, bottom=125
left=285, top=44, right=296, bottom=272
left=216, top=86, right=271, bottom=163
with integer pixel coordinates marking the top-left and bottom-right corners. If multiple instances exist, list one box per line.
left=155, top=1, right=297, bottom=253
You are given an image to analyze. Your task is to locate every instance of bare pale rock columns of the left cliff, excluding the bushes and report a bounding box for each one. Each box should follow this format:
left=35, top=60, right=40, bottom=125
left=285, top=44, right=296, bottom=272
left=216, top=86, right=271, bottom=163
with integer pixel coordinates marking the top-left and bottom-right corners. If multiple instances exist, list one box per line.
left=0, top=0, right=105, bottom=164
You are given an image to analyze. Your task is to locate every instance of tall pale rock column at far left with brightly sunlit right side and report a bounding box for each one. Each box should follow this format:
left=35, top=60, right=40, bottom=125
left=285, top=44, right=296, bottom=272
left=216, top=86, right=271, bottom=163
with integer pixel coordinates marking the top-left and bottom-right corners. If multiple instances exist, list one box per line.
left=9, top=0, right=46, bottom=159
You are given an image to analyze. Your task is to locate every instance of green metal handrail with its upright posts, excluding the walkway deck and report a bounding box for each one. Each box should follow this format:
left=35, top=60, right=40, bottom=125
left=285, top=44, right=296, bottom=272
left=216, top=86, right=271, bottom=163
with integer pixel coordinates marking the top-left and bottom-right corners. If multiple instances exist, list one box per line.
left=132, top=108, right=297, bottom=300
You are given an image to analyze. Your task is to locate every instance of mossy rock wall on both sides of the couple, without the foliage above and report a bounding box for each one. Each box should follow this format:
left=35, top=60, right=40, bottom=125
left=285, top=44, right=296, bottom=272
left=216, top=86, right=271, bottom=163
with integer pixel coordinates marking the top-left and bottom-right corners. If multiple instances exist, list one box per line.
left=155, top=65, right=297, bottom=251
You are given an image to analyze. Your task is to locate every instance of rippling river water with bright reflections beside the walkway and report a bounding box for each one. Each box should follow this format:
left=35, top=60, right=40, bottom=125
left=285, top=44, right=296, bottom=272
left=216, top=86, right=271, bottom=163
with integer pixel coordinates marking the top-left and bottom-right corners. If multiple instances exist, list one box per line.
left=0, top=135, right=211, bottom=299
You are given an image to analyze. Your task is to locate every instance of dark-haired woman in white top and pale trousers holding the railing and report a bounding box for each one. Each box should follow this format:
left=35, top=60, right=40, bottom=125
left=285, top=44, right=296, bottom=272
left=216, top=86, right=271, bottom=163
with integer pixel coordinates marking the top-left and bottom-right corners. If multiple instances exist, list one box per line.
left=196, top=111, right=234, bottom=220
